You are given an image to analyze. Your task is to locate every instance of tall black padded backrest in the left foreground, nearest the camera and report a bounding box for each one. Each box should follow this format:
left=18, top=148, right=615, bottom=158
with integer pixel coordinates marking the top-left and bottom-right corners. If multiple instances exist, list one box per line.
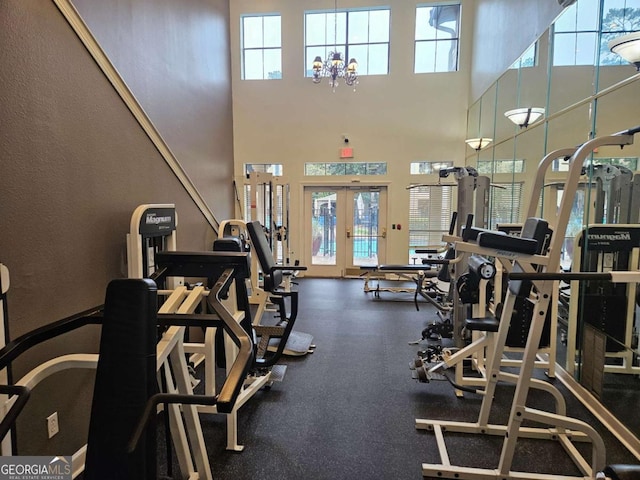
left=84, top=279, right=158, bottom=480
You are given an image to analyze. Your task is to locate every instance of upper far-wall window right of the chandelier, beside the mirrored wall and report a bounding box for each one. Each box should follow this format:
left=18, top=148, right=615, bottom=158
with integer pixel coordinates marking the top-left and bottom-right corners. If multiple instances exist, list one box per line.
left=414, top=3, right=460, bottom=73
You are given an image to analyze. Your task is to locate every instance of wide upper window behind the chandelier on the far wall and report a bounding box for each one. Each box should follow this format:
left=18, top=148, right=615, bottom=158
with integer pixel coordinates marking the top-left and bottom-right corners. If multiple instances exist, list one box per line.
left=304, top=8, right=390, bottom=77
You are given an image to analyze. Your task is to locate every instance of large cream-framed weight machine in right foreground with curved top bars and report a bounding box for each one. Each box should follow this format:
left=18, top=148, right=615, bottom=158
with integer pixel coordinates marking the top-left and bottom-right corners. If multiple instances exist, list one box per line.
left=416, top=127, right=640, bottom=480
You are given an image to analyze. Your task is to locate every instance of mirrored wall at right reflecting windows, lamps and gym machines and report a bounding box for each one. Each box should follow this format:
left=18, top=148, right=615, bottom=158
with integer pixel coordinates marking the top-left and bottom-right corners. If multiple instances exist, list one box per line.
left=466, top=0, right=640, bottom=444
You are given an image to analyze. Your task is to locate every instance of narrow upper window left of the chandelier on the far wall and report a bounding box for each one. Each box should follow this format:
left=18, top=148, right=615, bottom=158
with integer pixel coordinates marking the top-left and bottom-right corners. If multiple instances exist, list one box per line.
left=241, top=14, right=282, bottom=80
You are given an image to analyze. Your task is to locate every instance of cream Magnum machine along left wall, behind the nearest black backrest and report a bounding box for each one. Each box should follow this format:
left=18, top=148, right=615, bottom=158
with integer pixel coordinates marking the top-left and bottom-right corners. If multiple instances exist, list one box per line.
left=127, top=204, right=293, bottom=451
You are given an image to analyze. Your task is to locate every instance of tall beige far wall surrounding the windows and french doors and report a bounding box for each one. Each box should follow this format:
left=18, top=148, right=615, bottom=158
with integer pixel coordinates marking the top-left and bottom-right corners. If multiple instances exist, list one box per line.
left=231, top=0, right=473, bottom=263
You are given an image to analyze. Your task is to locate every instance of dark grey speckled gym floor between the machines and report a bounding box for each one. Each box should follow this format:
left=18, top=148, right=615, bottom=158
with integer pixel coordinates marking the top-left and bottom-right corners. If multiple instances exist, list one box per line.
left=161, top=278, right=635, bottom=480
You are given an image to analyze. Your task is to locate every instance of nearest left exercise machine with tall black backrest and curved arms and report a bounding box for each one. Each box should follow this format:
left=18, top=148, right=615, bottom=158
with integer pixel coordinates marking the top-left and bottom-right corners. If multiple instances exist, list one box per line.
left=0, top=255, right=253, bottom=480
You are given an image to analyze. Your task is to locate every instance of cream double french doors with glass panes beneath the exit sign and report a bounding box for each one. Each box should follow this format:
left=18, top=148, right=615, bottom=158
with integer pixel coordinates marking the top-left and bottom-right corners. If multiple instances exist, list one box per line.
left=304, top=186, right=387, bottom=277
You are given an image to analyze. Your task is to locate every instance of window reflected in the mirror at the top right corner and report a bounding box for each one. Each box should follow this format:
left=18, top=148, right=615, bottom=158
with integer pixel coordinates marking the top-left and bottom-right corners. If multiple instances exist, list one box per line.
left=553, top=0, right=640, bottom=66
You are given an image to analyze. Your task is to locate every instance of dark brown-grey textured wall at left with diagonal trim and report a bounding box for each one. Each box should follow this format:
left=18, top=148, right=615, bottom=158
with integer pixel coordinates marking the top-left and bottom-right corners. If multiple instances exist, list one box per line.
left=0, top=0, right=233, bottom=454
